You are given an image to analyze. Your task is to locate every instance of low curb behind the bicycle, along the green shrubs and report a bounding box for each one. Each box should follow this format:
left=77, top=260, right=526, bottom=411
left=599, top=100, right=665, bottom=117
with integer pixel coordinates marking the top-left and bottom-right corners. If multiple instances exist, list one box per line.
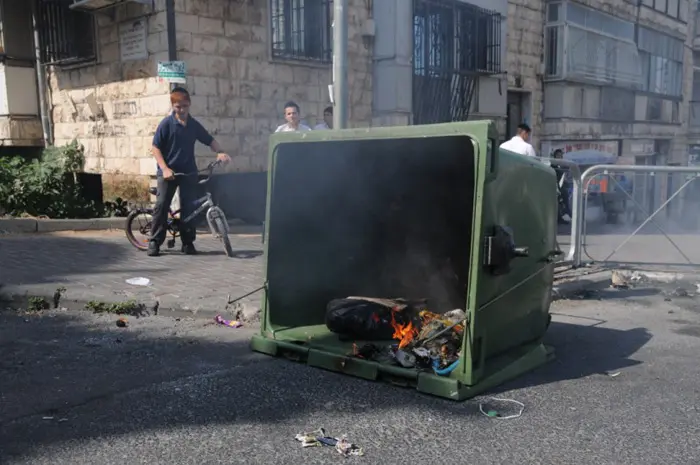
left=0, top=218, right=262, bottom=235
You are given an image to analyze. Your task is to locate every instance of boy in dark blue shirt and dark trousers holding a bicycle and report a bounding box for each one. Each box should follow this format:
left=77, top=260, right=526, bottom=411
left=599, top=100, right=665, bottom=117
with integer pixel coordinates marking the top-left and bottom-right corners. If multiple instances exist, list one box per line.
left=148, top=87, right=231, bottom=257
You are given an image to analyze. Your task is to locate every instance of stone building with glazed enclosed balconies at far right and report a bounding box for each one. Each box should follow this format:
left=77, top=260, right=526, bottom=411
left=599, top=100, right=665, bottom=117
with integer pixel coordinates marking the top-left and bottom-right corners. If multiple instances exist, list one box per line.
left=508, top=0, right=700, bottom=164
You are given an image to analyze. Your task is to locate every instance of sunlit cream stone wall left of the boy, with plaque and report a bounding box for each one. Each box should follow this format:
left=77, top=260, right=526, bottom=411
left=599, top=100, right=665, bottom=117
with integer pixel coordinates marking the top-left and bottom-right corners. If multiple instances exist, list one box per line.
left=48, top=2, right=169, bottom=175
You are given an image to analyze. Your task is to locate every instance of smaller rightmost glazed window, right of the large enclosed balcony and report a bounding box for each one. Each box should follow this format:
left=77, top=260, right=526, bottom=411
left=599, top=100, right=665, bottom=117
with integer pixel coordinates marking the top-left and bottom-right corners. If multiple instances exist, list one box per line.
left=638, top=27, right=684, bottom=97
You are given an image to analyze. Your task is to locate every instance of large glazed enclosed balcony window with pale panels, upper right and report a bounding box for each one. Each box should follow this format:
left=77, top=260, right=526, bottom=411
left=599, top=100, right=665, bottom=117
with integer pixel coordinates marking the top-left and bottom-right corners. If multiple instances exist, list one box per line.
left=545, top=3, right=641, bottom=87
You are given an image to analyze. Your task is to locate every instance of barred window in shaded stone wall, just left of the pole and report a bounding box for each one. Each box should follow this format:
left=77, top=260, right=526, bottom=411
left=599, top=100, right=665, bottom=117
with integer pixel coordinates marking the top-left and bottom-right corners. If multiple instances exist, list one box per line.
left=270, top=0, right=333, bottom=63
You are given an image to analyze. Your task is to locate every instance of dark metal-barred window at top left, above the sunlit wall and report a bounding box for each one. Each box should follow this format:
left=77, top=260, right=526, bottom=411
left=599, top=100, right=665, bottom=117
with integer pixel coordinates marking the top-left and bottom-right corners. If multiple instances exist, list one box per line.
left=38, top=0, right=97, bottom=66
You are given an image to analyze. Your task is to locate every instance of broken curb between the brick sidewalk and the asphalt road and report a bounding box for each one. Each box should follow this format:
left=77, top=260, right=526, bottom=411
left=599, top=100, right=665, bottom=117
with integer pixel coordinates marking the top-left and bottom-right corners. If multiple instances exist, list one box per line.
left=0, top=292, right=260, bottom=325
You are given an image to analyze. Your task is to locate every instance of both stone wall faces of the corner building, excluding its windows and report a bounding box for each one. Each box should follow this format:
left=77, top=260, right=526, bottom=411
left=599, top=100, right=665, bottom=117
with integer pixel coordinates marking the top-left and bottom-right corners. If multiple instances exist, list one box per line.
left=49, top=0, right=372, bottom=175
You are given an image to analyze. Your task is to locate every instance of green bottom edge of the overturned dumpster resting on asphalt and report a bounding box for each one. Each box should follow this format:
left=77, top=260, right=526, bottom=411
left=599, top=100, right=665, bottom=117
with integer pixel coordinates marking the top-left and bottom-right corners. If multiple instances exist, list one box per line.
left=251, top=335, right=554, bottom=401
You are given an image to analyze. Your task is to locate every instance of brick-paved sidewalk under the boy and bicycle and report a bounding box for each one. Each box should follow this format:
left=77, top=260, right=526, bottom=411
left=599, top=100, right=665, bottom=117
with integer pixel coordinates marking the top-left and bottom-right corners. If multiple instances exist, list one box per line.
left=0, top=232, right=263, bottom=313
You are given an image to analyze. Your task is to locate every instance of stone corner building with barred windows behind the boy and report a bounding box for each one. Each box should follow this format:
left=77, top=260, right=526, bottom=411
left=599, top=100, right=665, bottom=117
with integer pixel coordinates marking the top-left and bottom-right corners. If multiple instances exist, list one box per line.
left=0, top=0, right=507, bottom=189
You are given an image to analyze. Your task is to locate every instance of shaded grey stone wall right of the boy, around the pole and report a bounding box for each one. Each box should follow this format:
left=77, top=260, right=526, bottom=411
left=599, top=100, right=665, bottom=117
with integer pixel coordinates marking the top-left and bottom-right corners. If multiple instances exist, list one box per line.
left=176, top=0, right=372, bottom=171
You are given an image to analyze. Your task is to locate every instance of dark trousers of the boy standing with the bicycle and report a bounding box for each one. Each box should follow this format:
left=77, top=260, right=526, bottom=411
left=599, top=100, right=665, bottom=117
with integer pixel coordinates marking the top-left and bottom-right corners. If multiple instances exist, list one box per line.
left=151, top=176, right=197, bottom=247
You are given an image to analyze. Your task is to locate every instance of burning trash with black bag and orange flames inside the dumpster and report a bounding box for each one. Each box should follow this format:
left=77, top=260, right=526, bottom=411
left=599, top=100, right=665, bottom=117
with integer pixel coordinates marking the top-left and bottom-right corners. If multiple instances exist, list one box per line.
left=326, top=297, right=467, bottom=376
